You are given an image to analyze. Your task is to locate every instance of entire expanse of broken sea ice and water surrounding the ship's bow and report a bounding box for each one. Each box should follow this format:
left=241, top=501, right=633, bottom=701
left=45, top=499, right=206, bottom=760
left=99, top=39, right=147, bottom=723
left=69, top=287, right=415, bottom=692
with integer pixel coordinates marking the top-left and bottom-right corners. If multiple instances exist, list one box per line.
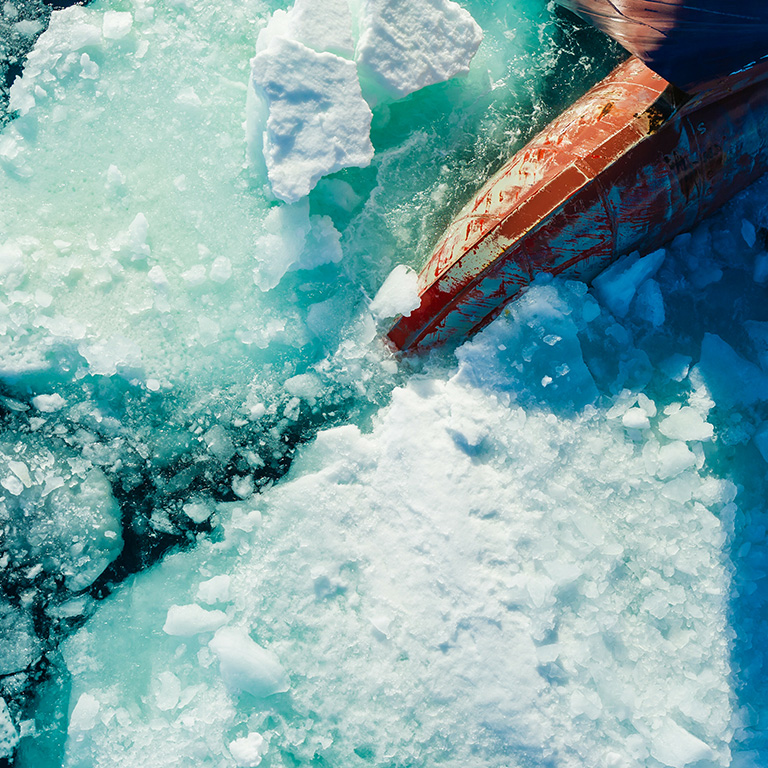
left=0, top=0, right=768, bottom=768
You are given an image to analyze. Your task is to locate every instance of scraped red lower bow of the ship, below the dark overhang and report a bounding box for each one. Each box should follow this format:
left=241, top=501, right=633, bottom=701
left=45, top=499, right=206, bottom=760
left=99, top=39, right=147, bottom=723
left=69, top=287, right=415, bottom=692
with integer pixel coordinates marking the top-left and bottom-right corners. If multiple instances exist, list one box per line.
left=389, top=57, right=768, bottom=350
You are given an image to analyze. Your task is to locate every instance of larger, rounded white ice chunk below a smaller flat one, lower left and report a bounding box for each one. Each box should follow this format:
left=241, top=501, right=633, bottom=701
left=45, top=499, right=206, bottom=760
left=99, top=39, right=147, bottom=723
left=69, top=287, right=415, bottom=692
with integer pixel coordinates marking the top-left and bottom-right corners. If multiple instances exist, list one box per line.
left=208, top=628, right=290, bottom=698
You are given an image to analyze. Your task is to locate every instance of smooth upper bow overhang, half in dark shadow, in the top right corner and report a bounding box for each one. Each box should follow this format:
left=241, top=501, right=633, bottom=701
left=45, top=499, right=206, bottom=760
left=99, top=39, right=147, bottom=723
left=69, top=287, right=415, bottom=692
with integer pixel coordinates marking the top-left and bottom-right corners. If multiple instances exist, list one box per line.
left=557, top=0, right=768, bottom=92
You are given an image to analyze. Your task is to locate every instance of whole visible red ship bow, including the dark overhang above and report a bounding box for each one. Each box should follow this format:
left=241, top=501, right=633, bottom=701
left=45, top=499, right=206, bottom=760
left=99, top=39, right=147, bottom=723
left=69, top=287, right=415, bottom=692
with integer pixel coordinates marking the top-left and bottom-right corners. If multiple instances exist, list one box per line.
left=389, top=0, right=768, bottom=350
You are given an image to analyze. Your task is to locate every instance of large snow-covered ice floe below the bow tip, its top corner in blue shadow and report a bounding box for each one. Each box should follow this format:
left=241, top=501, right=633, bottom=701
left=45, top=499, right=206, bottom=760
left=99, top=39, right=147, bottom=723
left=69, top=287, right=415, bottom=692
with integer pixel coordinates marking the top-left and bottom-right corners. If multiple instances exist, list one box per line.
left=57, top=285, right=736, bottom=768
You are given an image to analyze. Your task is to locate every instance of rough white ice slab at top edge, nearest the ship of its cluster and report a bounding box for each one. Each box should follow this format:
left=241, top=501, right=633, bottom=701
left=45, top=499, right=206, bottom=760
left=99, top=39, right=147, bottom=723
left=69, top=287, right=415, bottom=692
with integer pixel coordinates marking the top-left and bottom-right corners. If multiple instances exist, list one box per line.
left=356, top=0, right=483, bottom=98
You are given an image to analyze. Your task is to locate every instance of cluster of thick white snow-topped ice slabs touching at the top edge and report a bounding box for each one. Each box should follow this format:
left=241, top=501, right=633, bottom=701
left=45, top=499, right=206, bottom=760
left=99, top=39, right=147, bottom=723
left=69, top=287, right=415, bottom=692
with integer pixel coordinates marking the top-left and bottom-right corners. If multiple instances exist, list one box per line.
left=246, top=0, right=483, bottom=203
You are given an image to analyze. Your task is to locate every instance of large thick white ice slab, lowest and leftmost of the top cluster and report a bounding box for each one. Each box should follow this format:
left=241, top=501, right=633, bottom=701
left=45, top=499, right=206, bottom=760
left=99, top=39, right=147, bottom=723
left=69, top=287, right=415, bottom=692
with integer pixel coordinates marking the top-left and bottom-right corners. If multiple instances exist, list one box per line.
left=250, top=37, right=373, bottom=203
